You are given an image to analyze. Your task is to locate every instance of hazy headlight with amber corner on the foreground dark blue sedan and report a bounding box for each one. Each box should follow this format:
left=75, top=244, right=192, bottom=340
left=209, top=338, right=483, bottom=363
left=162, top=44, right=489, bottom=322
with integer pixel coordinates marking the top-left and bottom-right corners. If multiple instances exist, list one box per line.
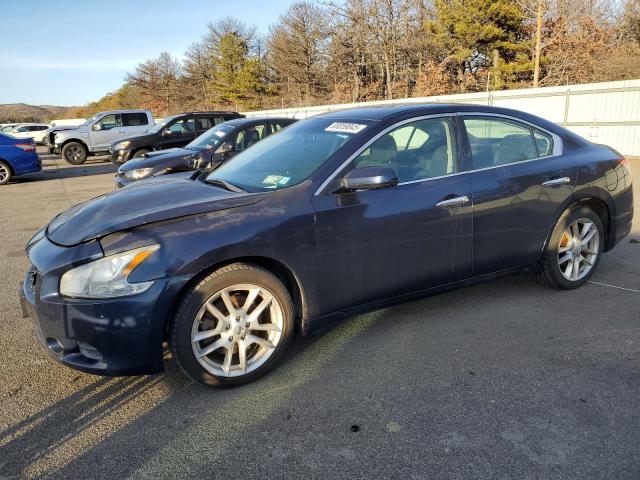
left=60, top=245, right=160, bottom=298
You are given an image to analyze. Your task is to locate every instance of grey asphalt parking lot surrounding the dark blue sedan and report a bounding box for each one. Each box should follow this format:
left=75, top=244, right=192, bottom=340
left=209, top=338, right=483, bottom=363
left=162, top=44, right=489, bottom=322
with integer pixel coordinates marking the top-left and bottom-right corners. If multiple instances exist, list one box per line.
left=0, top=151, right=640, bottom=480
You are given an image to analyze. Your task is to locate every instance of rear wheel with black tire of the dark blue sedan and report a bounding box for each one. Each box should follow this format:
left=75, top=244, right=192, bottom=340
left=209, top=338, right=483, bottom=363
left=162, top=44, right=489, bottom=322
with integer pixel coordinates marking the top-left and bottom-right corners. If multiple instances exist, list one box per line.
left=539, top=207, right=604, bottom=290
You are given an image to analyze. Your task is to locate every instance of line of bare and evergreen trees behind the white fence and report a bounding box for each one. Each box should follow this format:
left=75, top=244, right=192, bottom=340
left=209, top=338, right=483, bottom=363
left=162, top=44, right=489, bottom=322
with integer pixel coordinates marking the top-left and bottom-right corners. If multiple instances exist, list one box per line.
left=70, top=0, right=640, bottom=117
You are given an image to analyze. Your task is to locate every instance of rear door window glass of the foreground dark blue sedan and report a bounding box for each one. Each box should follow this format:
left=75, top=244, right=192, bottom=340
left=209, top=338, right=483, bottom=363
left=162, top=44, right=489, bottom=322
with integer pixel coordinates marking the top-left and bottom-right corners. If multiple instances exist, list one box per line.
left=464, top=118, right=538, bottom=168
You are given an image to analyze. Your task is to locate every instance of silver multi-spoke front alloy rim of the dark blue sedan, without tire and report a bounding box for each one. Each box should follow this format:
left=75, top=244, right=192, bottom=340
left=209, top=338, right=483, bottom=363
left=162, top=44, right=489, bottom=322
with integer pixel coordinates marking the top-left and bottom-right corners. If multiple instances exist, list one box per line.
left=191, top=283, right=284, bottom=377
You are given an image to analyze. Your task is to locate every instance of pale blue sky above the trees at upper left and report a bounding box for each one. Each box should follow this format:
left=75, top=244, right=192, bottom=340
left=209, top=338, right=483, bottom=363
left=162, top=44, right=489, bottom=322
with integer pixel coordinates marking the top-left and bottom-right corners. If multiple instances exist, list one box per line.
left=0, top=0, right=293, bottom=106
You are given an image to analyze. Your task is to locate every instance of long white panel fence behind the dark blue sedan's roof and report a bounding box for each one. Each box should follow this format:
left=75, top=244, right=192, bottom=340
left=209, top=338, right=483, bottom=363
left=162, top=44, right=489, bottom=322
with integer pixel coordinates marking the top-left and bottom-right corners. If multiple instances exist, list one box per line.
left=244, top=80, right=640, bottom=156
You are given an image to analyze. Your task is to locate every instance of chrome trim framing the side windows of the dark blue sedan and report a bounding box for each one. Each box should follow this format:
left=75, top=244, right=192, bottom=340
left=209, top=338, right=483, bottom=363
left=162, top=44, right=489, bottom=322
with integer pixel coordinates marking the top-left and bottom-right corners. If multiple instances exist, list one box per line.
left=314, top=112, right=564, bottom=196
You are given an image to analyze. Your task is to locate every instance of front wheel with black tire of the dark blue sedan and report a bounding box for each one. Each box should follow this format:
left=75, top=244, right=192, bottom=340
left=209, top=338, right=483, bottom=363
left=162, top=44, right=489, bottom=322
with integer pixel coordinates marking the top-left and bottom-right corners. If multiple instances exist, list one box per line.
left=169, top=263, right=294, bottom=387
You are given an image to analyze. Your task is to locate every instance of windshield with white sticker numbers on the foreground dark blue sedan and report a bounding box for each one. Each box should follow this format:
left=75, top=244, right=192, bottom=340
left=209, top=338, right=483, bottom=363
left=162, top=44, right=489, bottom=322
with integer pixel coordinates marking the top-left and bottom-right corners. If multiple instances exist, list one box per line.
left=206, top=118, right=370, bottom=192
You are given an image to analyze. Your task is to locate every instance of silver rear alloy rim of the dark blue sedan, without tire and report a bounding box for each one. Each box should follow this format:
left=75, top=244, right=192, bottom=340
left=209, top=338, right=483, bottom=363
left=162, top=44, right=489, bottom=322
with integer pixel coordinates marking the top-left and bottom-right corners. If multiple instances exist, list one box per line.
left=558, top=218, right=600, bottom=282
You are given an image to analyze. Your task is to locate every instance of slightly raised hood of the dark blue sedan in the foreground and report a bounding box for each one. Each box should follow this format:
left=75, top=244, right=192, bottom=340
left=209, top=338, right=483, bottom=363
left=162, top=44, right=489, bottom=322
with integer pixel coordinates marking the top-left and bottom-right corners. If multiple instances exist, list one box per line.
left=47, top=172, right=265, bottom=246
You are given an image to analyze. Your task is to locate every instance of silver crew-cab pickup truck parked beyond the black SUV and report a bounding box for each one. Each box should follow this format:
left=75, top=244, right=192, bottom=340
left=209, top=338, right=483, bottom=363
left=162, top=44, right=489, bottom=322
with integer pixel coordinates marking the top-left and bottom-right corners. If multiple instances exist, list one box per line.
left=53, top=110, right=153, bottom=165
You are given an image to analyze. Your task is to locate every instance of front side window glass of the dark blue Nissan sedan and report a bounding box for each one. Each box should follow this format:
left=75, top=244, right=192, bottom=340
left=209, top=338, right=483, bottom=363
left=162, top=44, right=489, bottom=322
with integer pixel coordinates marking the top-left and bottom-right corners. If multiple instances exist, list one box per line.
left=354, top=118, right=457, bottom=182
